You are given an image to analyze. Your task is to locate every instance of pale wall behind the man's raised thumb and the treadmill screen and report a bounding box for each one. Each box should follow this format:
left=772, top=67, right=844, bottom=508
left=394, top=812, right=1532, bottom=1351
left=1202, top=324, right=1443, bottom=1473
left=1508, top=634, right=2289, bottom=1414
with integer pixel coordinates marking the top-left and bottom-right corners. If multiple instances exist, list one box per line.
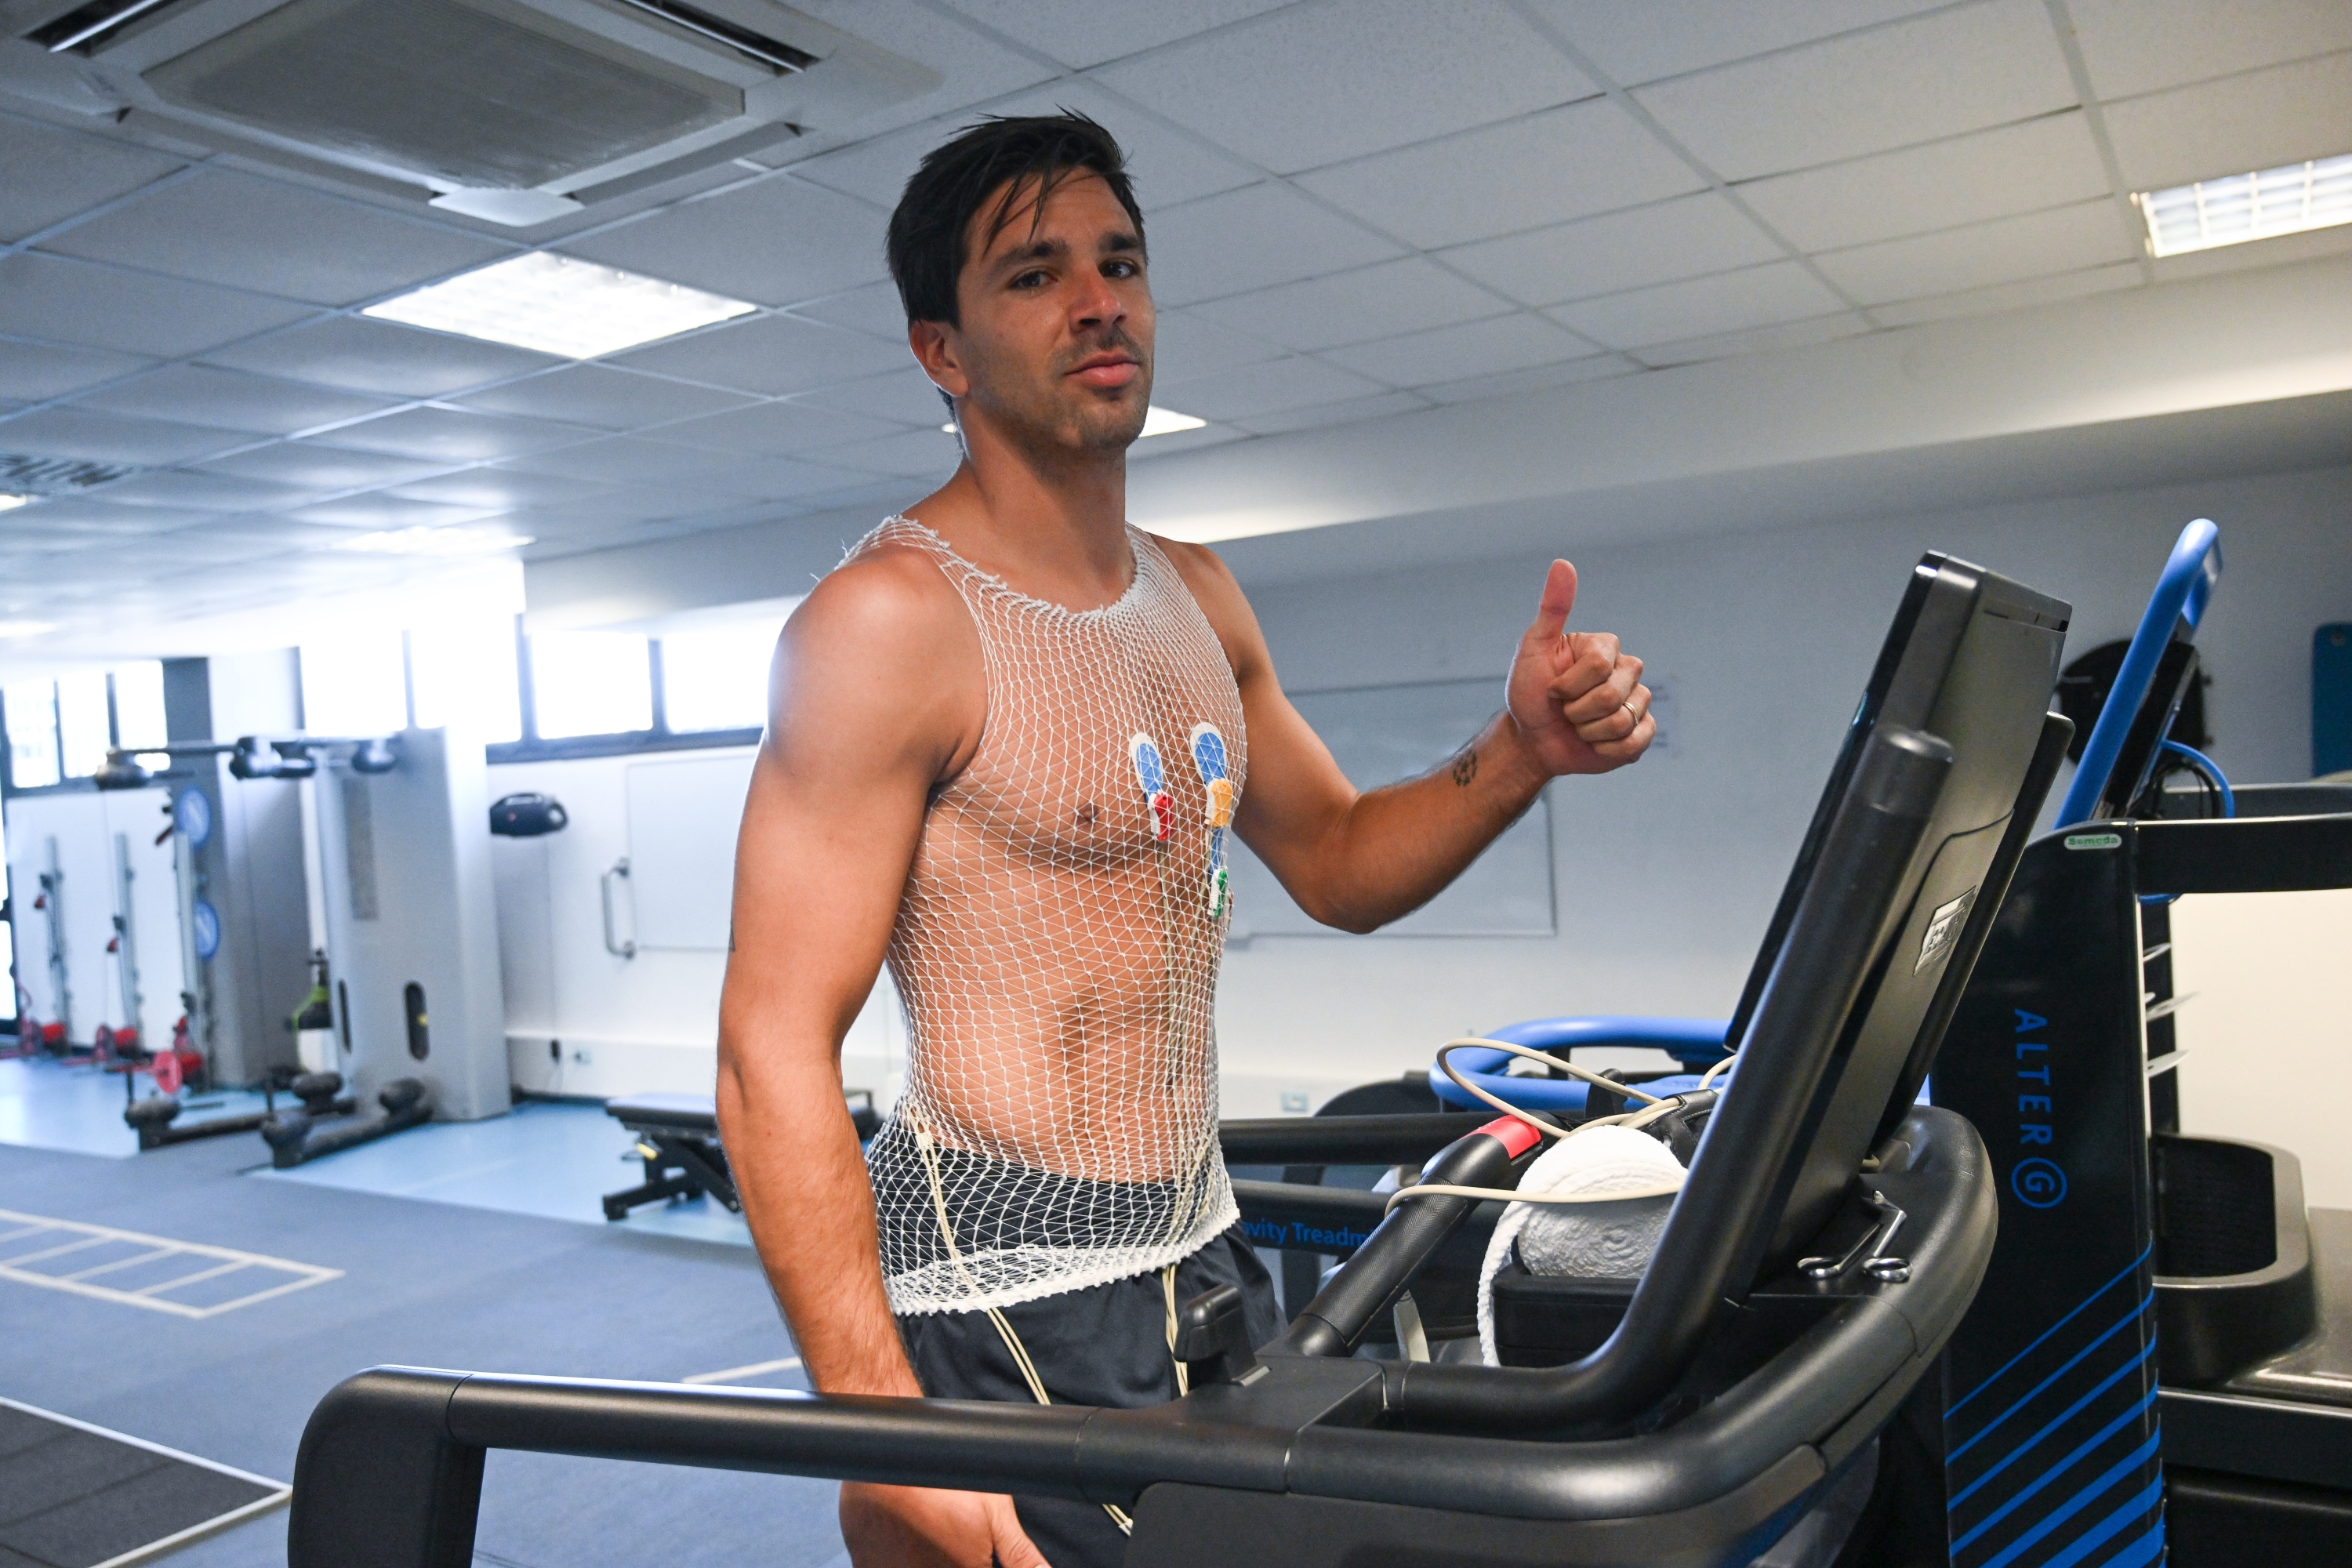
left=1218, top=468, right=2352, bottom=1102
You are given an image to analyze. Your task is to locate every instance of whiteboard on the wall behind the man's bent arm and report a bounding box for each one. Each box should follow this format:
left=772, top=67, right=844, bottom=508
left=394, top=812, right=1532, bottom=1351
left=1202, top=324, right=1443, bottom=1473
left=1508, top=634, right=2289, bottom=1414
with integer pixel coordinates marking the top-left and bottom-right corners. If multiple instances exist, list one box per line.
left=1232, top=680, right=1555, bottom=935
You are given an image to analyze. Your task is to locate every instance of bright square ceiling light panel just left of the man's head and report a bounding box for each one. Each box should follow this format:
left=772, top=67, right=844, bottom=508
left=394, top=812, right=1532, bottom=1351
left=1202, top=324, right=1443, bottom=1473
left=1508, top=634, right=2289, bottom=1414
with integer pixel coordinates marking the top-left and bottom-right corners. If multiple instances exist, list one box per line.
left=360, top=252, right=757, bottom=360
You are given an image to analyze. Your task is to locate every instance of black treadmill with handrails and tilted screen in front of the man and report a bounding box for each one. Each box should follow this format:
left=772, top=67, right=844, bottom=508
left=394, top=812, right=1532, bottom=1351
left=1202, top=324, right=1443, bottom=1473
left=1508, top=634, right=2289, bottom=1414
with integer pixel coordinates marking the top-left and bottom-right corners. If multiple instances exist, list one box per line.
left=287, top=555, right=2072, bottom=1568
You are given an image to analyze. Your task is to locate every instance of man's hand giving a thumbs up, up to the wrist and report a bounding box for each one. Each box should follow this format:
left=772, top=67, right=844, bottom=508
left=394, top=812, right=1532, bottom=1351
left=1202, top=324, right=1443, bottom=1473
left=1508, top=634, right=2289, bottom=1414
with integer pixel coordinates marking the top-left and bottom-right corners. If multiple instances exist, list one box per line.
left=1508, top=562, right=1658, bottom=776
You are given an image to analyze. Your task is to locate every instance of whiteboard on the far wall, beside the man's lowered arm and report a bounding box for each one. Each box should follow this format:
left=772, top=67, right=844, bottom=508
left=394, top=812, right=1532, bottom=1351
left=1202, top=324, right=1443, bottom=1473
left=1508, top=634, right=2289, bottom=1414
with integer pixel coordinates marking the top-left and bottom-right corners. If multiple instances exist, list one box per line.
left=628, top=750, right=757, bottom=952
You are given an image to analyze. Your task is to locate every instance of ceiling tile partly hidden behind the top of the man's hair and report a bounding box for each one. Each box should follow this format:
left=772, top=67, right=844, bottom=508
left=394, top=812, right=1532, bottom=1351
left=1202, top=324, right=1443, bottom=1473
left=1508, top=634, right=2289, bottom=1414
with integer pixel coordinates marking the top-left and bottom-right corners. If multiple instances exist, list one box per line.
left=793, top=78, right=1263, bottom=212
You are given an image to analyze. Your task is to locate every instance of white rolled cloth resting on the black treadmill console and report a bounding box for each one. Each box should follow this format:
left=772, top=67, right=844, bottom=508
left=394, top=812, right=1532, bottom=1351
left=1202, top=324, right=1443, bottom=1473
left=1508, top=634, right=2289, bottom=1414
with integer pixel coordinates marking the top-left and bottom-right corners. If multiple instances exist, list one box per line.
left=1477, top=1126, right=1686, bottom=1366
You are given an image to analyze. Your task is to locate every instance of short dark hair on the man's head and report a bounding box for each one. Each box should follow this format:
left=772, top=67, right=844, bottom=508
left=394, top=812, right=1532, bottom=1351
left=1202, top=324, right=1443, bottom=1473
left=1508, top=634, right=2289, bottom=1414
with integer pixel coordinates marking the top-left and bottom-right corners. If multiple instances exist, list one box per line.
left=884, top=108, right=1143, bottom=327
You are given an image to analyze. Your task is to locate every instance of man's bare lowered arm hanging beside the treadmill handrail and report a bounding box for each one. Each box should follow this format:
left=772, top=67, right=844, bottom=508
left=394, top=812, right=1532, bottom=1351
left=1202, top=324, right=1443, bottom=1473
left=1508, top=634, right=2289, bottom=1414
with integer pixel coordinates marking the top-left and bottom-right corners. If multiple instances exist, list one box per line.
left=717, top=553, right=1044, bottom=1568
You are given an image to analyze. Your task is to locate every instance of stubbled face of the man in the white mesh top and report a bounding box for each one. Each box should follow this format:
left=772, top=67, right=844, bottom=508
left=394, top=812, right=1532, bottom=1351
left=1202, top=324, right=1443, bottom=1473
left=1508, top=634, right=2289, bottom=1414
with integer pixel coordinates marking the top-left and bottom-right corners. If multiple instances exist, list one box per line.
left=943, top=174, right=1155, bottom=454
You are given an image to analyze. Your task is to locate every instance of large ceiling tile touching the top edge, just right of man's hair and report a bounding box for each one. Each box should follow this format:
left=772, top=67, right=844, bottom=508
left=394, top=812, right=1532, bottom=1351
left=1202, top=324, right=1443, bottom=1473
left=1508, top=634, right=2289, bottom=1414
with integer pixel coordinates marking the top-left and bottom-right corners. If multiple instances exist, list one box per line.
left=1096, top=0, right=1597, bottom=174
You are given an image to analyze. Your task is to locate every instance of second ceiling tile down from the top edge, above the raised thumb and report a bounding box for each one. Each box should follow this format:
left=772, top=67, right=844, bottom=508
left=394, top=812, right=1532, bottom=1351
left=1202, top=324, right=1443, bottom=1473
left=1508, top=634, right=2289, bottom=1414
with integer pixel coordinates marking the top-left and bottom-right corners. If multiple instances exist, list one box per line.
left=1298, top=99, right=1708, bottom=249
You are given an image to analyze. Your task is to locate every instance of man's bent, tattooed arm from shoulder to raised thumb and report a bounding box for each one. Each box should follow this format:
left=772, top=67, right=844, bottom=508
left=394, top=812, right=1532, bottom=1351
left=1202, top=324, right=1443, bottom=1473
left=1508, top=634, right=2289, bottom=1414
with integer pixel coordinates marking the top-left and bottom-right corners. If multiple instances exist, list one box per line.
left=1171, top=546, right=1658, bottom=931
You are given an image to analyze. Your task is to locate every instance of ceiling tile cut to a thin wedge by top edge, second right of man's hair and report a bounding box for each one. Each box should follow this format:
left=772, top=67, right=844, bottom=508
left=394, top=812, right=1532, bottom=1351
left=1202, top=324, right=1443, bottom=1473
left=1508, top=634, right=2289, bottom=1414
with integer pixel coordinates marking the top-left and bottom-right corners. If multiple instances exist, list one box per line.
left=1534, top=0, right=1945, bottom=87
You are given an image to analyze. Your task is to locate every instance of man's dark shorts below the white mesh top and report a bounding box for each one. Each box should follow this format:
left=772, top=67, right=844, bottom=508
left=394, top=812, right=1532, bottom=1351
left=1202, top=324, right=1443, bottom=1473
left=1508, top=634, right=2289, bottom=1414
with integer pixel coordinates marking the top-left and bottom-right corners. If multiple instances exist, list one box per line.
left=898, top=1225, right=1284, bottom=1568
